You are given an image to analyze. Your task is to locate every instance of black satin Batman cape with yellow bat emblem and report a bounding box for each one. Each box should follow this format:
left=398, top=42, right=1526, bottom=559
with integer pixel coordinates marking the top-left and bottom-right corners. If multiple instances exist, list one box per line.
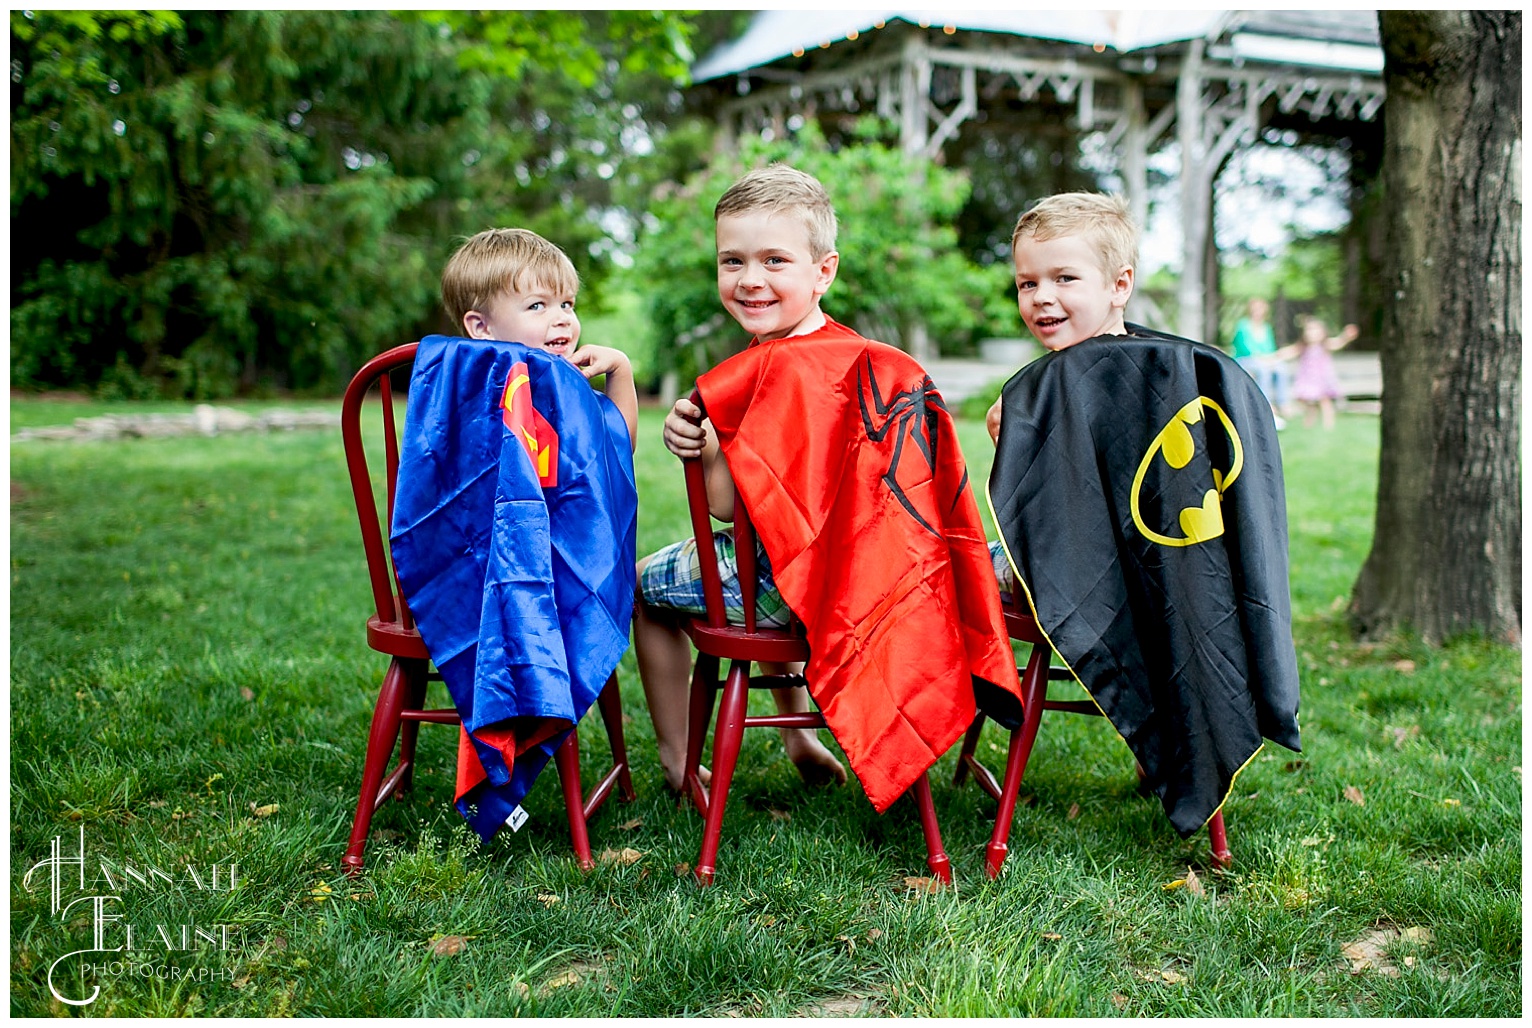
left=988, top=325, right=1299, bottom=836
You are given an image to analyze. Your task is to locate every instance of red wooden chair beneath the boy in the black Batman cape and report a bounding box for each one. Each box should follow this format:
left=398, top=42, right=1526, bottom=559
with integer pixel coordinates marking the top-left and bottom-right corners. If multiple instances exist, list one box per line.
left=953, top=581, right=1233, bottom=878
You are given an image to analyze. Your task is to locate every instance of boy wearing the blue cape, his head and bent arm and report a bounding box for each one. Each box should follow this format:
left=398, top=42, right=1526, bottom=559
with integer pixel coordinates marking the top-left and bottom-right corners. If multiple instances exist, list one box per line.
left=441, top=228, right=639, bottom=447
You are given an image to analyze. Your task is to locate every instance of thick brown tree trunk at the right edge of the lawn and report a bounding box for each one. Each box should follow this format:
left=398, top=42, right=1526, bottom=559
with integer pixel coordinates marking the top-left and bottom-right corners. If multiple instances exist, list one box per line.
left=1351, top=11, right=1521, bottom=643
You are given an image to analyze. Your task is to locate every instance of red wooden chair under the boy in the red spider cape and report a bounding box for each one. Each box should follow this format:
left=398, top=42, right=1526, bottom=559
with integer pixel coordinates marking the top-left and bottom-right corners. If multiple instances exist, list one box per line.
left=682, top=392, right=951, bottom=886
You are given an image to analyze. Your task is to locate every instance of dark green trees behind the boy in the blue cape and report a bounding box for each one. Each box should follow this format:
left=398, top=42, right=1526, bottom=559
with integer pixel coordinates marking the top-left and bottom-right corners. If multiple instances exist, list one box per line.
left=11, top=11, right=691, bottom=397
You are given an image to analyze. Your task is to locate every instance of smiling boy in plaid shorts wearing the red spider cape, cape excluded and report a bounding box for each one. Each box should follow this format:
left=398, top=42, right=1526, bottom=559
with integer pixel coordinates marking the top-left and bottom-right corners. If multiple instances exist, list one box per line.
left=633, top=164, right=846, bottom=791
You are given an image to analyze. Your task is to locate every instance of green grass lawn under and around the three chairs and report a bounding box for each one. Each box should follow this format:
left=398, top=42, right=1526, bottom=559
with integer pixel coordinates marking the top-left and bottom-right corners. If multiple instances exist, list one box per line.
left=11, top=400, right=1521, bottom=1017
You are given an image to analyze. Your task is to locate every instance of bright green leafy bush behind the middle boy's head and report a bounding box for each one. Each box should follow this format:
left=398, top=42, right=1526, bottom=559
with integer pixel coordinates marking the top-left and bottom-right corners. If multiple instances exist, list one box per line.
left=634, top=123, right=1008, bottom=377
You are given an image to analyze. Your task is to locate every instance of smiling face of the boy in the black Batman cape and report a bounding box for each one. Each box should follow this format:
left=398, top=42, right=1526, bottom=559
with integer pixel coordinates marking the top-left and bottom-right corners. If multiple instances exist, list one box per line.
left=1014, top=236, right=1134, bottom=349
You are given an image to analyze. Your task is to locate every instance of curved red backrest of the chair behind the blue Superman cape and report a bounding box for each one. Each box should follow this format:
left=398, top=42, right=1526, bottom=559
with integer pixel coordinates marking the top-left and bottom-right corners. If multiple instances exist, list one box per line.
left=340, top=343, right=418, bottom=633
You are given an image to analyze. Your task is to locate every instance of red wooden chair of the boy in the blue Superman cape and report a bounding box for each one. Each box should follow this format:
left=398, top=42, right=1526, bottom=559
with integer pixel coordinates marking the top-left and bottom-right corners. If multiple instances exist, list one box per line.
left=340, top=343, right=634, bottom=875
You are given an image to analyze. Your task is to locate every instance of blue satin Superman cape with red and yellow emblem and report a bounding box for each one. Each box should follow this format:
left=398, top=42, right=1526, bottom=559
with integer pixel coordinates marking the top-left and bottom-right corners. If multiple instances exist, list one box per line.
left=391, top=336, right=637, bottom=841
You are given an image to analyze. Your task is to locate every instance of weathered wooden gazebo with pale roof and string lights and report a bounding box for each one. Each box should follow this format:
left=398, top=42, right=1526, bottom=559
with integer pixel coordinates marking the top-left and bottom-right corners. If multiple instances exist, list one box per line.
left=692, top=9, right=1383, bottom=355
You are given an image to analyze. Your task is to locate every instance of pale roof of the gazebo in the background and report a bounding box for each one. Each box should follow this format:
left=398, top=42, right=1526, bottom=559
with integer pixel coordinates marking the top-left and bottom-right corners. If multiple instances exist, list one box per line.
left=692, top=9, right=1383, bottom=83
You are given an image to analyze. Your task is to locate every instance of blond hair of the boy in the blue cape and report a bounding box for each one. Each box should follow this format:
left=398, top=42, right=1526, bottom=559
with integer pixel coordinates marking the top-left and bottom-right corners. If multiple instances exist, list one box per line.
left=441, top=228, right=579, bottom=328
